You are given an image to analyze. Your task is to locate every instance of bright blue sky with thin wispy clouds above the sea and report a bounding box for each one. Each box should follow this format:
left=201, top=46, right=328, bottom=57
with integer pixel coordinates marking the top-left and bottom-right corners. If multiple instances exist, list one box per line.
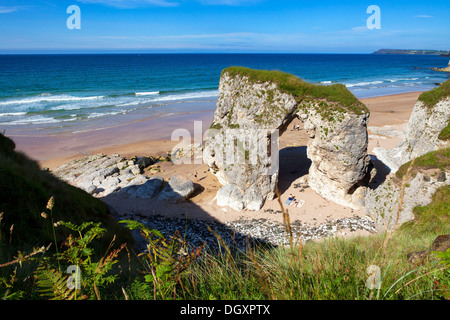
left=0, top=0, right=450, bottom=53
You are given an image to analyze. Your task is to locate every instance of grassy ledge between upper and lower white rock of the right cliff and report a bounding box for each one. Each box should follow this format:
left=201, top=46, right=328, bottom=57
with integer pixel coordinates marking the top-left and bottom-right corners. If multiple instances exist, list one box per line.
left=395, top=148, right=450, bottom=179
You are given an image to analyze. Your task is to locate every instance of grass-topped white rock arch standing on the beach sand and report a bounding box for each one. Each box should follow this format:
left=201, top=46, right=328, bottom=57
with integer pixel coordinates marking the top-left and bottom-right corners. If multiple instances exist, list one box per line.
left=203, top=67, right=370, bottom=210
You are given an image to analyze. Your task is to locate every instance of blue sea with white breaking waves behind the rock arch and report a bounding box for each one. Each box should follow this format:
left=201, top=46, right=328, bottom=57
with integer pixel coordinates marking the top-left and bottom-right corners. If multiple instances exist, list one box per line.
left=0, top=54, right=449, bottom=133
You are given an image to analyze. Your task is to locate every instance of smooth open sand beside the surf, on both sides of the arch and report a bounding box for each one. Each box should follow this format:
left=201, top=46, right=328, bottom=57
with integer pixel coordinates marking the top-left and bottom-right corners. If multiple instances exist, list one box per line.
left=7, top=91, right=422, bottom=169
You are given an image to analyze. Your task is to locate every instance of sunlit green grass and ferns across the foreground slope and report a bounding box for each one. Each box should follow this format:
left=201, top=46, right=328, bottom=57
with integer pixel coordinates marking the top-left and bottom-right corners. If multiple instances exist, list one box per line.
left=0, top=195, right=449, bottom=300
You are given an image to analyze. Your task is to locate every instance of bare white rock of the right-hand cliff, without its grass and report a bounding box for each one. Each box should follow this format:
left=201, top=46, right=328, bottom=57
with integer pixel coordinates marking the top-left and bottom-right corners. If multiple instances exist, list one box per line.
left=365, top=84, right=450, bottom=231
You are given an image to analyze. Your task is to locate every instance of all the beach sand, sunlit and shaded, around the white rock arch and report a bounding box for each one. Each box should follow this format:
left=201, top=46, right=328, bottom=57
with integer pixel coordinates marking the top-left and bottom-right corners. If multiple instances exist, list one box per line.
left=8, top=92, right=421, bottom=236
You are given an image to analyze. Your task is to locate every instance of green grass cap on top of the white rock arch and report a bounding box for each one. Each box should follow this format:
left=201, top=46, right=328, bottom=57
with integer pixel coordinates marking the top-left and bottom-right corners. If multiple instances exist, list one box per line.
left=222, top=66, right=369, bottom=115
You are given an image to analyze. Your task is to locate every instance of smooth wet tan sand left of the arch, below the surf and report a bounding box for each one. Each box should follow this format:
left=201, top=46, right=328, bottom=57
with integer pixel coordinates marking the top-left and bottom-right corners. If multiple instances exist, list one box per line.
left=8, top=111, right=214, bottom=169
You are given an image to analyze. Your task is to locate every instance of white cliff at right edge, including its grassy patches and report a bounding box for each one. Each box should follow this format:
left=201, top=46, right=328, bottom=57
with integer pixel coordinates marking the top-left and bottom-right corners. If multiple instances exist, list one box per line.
left=365, top=80, right=450, bottom=231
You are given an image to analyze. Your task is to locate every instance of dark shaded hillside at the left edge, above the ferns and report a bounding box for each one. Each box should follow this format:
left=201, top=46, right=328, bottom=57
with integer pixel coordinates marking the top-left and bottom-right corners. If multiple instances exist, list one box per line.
left=0, top=134, right=133, bottom=247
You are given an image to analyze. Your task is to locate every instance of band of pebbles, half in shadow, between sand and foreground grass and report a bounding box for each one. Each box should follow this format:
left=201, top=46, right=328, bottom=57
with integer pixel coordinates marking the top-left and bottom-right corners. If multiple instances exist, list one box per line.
left=116, top=213, right=376, bottom=251
